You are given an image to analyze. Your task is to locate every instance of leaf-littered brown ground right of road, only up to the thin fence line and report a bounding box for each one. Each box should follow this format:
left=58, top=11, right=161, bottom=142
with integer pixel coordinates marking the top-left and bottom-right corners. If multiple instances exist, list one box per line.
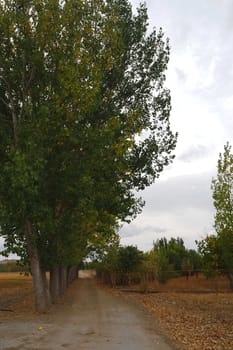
left=119, top=293, right=233, bottom=350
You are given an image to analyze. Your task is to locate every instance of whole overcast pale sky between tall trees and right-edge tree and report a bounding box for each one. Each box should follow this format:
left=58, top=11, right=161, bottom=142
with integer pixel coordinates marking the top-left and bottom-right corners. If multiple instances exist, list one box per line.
left=120, top=0, right=233, bottom=250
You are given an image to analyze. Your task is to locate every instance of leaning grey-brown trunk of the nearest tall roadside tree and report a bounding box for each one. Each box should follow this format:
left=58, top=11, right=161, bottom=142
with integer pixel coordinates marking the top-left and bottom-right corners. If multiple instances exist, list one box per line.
left=25, top=221, right=50, bottom=312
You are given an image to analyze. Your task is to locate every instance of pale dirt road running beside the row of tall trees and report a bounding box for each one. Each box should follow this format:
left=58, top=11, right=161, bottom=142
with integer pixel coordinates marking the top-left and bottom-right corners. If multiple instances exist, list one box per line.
left=0, top=279, right=173, bottom=350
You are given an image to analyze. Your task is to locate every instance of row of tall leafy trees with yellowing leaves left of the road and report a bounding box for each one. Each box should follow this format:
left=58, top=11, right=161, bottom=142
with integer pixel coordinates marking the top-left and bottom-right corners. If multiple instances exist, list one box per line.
left=0, top=0, right=176, bottom=311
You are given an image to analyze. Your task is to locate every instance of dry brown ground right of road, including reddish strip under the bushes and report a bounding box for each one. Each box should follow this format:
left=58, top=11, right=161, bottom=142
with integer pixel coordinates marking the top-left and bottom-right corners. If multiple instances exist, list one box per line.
left=110, top=275, right=233, bottom=350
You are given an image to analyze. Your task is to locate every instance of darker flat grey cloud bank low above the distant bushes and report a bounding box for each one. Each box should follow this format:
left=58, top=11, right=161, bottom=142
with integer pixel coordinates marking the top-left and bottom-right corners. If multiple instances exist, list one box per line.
left=120, top=173, right=214, bottom=250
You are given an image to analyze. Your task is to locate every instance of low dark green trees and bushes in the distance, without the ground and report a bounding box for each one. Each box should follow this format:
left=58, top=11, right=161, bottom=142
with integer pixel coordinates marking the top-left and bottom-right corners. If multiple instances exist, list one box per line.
left=91, top=237, right=203, bottom=282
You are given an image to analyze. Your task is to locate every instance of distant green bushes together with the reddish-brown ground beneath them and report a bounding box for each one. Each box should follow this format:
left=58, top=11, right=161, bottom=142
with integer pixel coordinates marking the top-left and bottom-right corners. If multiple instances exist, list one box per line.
left=90, top=237, right=232, bottom=293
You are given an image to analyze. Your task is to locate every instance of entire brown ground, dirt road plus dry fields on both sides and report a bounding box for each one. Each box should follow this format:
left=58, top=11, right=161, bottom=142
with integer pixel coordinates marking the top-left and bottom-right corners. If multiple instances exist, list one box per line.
left=0, top=274, right=233, bottom=350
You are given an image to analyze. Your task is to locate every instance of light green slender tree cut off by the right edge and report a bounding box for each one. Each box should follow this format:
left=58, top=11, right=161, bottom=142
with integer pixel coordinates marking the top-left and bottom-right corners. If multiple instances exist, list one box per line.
left=198, top=143, right=233, bottom=286
